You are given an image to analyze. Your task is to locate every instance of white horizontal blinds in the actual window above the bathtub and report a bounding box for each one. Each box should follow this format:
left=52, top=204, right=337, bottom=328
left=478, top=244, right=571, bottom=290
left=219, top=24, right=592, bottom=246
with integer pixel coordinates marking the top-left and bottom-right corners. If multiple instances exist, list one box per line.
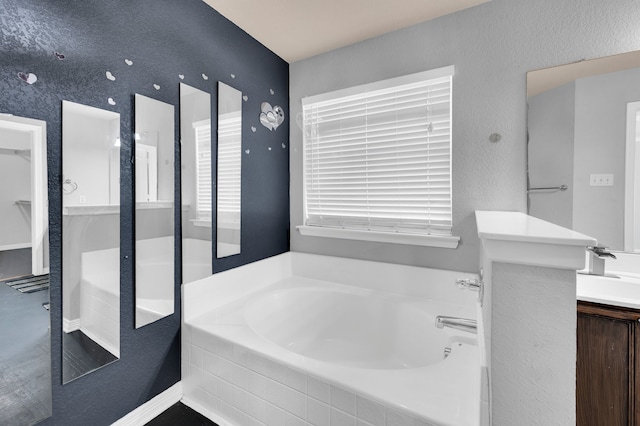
left=302, top=67, right=453, bottom=235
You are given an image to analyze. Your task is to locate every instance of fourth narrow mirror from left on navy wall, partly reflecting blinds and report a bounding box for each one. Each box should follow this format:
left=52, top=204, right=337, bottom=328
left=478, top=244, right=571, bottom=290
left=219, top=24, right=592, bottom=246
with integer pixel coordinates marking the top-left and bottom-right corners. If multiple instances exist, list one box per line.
left=180, top=83, right=213, bottom=283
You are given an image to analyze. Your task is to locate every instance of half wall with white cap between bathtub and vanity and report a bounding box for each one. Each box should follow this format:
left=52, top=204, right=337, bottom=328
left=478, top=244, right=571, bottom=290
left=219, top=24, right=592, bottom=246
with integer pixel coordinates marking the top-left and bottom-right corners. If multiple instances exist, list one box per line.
left=476, top=211, right=596, bottom=426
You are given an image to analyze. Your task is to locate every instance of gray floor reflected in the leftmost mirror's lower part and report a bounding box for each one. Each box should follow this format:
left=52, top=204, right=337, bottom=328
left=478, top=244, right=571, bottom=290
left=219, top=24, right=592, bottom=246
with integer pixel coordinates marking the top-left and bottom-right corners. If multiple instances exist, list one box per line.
left=0, top=283, right=51, bottom=426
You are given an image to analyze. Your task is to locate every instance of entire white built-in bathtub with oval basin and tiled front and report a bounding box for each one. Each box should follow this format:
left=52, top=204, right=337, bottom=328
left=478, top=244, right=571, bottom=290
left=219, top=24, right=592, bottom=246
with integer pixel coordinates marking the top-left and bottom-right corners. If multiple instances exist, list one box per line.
left=182, top=253, right=480, bottom=426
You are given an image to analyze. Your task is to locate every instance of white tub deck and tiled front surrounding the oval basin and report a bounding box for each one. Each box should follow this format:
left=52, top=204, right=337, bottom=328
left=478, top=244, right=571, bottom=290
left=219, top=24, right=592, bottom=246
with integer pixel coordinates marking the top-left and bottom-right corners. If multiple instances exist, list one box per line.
left=182, top=253, right=480, bottom=426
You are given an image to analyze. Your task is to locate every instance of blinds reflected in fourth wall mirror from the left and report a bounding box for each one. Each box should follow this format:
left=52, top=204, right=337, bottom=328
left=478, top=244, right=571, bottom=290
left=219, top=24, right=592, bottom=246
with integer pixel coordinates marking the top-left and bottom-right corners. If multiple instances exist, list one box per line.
left=193, top=120, right=212, bottom=221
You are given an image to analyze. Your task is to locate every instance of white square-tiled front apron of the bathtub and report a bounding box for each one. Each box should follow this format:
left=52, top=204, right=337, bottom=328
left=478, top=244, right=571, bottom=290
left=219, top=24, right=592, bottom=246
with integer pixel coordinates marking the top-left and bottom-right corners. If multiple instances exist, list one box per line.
left=182, top=336, right=442, bottom=426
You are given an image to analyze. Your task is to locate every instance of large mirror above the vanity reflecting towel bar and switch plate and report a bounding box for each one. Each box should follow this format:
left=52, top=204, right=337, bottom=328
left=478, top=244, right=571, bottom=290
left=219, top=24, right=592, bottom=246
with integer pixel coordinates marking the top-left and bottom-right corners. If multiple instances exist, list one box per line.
left=527, top=52, right=640, bottom=252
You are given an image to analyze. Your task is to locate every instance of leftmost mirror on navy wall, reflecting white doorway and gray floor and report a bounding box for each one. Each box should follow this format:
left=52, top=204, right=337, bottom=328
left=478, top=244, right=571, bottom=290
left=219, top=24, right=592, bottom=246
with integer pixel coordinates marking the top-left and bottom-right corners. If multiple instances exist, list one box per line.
left=0, top=115, right=51, bottom=426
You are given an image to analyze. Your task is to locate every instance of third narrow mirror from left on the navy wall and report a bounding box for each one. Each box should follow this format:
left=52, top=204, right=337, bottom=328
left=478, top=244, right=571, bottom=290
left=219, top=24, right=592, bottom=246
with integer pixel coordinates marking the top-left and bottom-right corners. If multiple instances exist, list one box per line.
left=134, top=94, right=175, bottom=328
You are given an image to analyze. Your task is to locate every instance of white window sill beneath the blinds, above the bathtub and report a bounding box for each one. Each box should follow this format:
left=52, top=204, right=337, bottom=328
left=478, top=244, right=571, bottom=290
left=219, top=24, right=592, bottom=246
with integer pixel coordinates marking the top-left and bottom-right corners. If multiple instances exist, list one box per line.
left=296, top=225, right=460, bottom=248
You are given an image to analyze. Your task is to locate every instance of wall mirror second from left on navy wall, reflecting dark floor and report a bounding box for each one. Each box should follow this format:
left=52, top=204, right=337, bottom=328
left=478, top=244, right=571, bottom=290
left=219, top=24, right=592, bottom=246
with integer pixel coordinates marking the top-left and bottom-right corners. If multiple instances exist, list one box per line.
left=62, top=101, right=120, bottom=383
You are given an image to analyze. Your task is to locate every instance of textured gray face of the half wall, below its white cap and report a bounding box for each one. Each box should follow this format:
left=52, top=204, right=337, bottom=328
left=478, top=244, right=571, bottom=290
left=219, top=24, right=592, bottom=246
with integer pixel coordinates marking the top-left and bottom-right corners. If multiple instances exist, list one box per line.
left=490, top=263, right=576, bottom=426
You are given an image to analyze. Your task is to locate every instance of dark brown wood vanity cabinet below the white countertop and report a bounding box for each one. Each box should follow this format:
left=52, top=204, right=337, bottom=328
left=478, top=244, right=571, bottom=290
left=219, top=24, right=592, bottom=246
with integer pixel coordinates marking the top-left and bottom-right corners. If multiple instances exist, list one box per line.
left=576, top=301, right=640, bottom=426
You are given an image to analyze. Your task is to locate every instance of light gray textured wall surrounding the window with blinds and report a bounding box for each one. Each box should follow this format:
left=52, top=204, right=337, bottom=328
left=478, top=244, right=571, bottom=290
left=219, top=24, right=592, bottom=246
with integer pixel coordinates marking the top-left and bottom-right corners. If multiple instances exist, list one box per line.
left=290, top=0, right=640, bottom=272
